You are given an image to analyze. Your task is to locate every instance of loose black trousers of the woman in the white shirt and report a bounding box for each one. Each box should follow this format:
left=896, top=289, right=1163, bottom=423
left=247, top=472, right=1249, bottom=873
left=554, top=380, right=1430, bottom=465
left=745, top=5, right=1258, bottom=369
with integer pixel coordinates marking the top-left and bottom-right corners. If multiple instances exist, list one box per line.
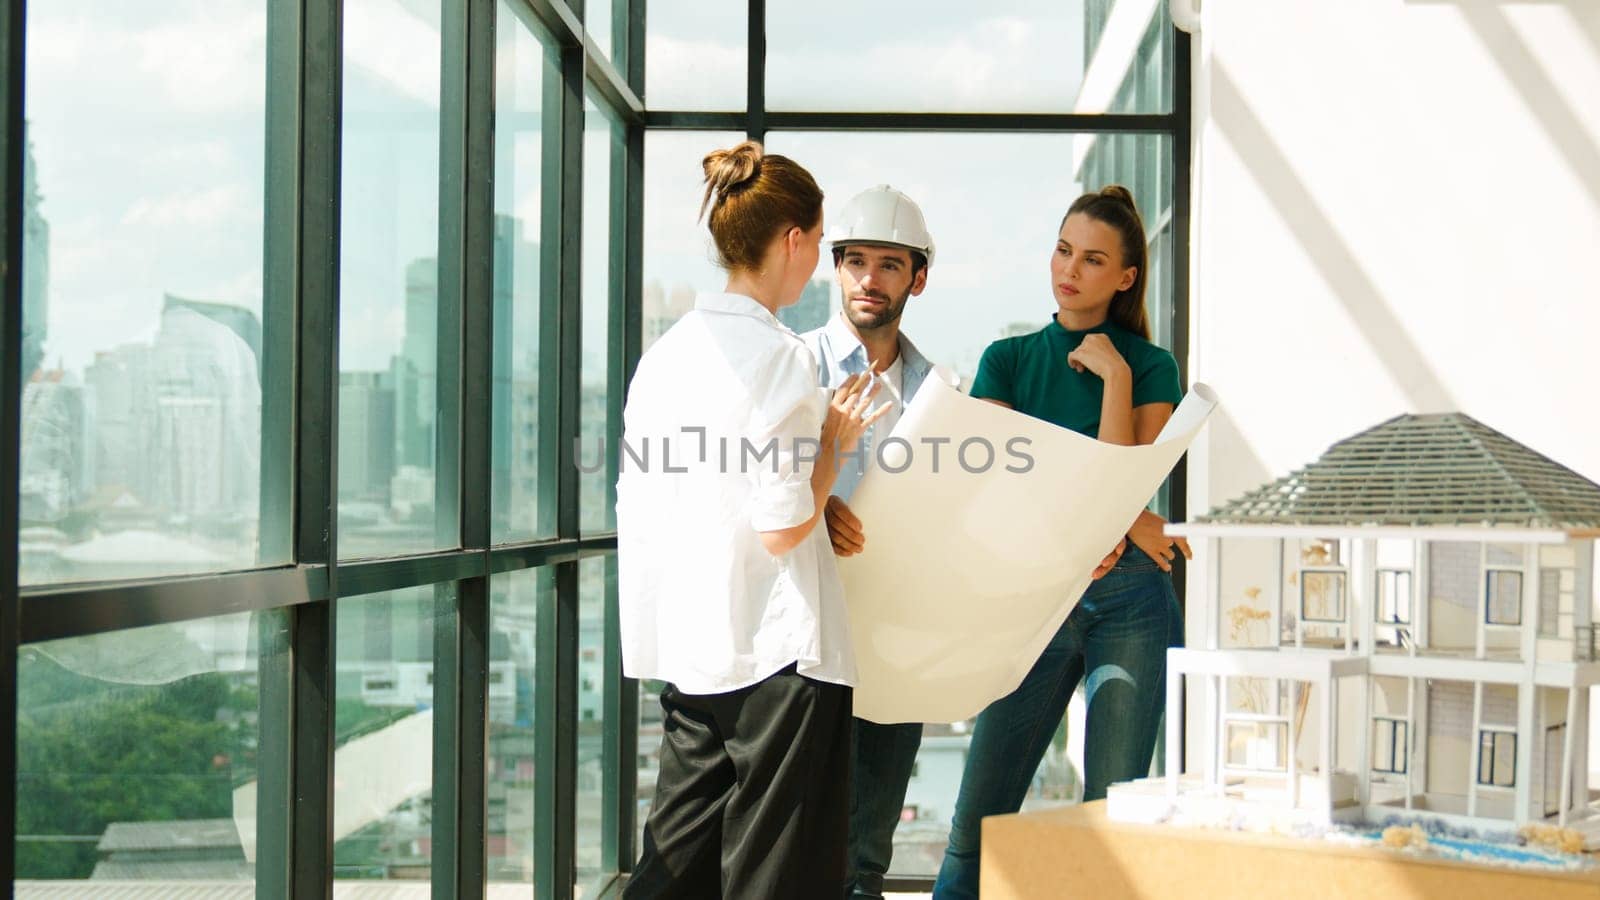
left=622, top=666, right=851, bottom=900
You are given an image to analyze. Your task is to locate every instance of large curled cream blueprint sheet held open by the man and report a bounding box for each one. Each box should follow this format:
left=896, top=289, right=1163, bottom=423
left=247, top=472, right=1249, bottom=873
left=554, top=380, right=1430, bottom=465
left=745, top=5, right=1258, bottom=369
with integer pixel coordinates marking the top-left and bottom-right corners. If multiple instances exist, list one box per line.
left=838, top=378, right=1216, bottom=724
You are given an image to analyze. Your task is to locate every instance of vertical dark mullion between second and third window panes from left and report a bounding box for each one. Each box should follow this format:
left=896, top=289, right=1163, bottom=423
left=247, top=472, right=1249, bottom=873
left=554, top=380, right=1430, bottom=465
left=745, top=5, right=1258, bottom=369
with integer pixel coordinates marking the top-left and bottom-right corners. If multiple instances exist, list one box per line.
left=432, top=0, right=496, bottom=900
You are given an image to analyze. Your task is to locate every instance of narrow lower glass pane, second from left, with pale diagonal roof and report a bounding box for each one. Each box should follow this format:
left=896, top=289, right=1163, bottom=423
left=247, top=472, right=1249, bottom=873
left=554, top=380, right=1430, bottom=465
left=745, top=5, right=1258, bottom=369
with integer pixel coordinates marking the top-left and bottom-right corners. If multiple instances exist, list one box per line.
left=333, top=585, right=438, bottom=882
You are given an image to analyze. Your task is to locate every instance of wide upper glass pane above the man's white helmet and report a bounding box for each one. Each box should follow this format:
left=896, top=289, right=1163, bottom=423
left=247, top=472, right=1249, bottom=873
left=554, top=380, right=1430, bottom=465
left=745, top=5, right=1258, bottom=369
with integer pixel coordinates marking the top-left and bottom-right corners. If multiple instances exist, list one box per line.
left=768, top=0, right=1173, bottom=112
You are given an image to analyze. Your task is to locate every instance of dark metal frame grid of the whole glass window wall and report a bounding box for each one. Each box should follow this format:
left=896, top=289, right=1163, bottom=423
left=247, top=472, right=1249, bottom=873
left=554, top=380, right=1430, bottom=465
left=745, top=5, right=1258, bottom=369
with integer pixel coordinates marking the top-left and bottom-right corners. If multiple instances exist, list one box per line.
left=0, top=0, right=1190, bottom=898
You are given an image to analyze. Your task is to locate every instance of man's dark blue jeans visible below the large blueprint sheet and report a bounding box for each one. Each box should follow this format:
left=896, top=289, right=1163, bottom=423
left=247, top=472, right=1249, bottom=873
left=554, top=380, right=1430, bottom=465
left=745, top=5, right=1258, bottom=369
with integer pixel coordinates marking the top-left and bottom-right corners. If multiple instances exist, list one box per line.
left=846, top=719, right=922, bottom=898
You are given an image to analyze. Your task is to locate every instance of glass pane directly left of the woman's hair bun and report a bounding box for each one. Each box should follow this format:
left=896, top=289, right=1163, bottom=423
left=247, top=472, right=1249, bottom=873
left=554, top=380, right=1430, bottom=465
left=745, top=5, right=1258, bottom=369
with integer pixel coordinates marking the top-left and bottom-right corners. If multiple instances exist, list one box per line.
left=643, top=129, right=744, bottom=351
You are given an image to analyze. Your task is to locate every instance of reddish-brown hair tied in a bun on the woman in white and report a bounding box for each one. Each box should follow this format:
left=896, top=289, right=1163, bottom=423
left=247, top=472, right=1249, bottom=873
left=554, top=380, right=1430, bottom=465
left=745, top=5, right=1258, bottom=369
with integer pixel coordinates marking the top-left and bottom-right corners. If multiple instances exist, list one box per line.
left=701, top=141, right=822, bottom=271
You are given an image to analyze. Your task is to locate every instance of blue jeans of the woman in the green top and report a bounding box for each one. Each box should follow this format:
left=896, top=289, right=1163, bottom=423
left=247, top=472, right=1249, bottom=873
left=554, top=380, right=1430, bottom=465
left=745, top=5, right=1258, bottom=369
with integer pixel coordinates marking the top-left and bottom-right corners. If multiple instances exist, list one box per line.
left=933, top=543, right=1184, bottom=900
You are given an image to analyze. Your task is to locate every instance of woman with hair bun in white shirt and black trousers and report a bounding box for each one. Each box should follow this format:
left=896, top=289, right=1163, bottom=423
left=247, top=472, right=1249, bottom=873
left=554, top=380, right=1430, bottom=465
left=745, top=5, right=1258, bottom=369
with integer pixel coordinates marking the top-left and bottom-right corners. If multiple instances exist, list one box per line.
left=616, top=141, right=886, bottom=898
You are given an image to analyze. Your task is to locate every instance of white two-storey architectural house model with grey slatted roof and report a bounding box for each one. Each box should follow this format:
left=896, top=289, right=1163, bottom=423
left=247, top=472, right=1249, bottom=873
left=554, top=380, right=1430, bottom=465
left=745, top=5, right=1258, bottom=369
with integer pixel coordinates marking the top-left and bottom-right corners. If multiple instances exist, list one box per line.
left=1109, top=413, right=1600, bottom=844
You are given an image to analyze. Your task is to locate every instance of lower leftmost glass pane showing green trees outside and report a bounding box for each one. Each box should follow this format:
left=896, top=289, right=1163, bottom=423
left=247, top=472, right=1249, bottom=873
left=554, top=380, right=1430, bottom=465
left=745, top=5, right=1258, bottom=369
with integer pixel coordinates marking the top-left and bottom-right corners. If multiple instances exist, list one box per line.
left=16, top=610, right=288, bottom=877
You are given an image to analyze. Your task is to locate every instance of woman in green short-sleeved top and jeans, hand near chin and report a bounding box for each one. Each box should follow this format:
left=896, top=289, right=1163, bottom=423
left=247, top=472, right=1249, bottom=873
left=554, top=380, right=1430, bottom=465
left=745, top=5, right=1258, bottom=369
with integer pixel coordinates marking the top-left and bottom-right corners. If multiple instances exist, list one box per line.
left=933, top=184, right=1189, bottom=900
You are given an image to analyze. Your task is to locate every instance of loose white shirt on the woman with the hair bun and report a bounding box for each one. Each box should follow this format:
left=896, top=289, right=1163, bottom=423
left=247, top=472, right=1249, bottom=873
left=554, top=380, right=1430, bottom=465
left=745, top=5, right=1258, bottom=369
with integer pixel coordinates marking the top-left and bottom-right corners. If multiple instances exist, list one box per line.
left=616, top=293, right=856, bottom=693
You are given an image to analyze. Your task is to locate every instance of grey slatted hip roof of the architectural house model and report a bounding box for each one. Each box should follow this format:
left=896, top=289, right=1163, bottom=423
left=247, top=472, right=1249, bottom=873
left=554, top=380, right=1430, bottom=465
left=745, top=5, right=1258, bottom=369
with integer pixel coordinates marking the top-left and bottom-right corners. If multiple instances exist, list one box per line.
left=1198, top=413, right=1600, bottom=532
